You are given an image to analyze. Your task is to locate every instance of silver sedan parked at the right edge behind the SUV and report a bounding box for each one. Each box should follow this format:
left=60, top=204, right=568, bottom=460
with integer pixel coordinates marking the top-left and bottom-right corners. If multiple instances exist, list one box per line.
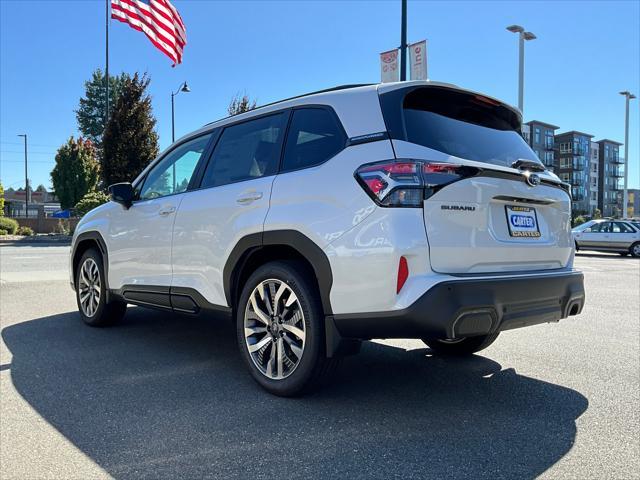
left=572, top=219, right=640, bottom=257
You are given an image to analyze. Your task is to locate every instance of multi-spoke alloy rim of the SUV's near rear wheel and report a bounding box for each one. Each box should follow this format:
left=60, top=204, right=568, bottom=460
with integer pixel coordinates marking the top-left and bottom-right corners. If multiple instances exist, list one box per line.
left=244, top=279, right=306, bottom=380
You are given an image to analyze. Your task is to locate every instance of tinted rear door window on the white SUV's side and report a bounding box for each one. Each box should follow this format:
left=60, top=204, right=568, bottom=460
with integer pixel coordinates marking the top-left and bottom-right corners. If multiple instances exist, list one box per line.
left=202, top=113, right=285, bottom=187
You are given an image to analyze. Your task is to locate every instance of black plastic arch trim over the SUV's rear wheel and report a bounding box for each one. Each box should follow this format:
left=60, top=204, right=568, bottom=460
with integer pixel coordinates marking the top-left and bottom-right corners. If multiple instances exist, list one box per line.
left=223, top=230, right=333, bottom=315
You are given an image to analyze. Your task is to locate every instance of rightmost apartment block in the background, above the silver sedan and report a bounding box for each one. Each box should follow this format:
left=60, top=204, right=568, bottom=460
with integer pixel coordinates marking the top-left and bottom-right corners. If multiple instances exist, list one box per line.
left=595, top=138, right=624, bottom=217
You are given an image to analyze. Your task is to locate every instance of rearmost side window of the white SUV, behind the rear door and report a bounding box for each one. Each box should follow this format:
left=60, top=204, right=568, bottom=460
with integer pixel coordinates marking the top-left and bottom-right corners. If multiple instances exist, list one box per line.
left=282, top=108, right=347, bottom=170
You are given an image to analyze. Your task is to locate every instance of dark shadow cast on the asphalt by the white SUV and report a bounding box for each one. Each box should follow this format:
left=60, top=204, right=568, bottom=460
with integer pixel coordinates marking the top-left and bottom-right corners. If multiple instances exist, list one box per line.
left=2, top=308, right=588, bottom=479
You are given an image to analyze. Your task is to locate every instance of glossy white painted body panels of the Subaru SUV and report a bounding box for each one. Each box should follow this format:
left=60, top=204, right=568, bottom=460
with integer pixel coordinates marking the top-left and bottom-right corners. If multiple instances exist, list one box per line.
left=74, top=82, right=573, bottom=320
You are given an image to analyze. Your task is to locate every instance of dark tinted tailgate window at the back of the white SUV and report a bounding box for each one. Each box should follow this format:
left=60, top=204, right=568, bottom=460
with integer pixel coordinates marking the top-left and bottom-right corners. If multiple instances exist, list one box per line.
left=381, top=87, right=540, bottom=167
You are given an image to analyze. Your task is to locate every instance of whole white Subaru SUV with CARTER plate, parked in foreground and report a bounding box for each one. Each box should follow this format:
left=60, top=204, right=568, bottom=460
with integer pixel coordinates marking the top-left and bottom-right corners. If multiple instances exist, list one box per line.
left=70, top=81, right=585, bottom=395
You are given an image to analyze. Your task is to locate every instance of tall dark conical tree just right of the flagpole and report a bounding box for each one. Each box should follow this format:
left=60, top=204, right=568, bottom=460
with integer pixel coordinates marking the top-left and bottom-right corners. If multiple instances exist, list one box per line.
left=101, top=73, right=159, bottom=185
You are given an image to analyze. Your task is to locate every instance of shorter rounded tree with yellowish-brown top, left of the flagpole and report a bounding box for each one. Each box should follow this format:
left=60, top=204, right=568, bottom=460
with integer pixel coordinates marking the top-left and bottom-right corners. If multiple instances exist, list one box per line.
left=51, top=137, right=100, bottom=209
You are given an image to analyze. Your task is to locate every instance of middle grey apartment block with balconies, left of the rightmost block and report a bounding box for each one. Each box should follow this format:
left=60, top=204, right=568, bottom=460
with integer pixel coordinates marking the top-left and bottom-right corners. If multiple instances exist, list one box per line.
left=556, top=130, right=602, bottom=215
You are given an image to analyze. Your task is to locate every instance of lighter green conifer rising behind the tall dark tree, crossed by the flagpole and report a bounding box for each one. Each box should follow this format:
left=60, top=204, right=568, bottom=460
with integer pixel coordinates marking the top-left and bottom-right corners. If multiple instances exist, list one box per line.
left=75, top=69, right=129, bottom=150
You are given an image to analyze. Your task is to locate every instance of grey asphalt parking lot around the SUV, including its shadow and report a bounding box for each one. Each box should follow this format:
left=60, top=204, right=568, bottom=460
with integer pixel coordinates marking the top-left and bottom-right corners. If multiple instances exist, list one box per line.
left=0, top=246, right=640, bottom=480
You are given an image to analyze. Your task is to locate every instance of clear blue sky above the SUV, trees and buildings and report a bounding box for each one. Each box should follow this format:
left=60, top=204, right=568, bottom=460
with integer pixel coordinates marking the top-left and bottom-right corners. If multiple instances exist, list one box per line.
left=0, top=0, right=640, bottom=188
